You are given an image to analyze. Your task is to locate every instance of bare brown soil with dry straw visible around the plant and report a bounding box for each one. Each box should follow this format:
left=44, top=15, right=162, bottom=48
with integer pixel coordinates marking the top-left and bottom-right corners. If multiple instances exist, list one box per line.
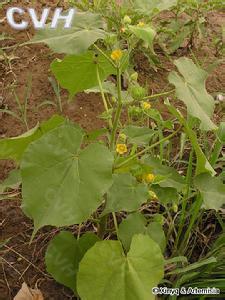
left=0, top=0, right=225, bottom=300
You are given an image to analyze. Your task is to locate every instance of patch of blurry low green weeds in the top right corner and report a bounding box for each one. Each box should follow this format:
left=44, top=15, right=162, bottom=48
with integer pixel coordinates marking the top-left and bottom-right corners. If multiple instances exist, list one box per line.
left=159, top=0, right=222, bottom=54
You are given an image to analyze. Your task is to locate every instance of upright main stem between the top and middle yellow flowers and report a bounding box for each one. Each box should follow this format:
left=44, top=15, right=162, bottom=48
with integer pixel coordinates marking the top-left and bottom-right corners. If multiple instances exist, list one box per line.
left=110, top=66, right=123, bottom=150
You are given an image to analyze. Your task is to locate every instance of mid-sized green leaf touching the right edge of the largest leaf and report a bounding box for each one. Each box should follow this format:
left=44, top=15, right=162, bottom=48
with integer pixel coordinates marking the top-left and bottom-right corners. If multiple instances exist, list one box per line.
left=104, top=174, right=148, bottom=213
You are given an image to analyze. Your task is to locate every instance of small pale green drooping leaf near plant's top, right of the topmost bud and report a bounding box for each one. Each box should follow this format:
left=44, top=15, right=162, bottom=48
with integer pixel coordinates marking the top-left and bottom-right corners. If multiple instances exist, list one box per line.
left=129, top=25, right=156, bottom=53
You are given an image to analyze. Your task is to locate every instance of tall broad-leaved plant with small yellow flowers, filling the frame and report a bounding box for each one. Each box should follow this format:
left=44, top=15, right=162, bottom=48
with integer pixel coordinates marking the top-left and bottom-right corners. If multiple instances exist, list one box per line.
left=0, top=1, right=225, bottom=300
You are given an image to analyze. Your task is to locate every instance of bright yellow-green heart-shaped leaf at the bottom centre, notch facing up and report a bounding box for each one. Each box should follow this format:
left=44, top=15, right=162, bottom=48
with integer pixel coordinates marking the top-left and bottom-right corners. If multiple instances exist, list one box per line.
left=77, top=234, right=164, bottom=300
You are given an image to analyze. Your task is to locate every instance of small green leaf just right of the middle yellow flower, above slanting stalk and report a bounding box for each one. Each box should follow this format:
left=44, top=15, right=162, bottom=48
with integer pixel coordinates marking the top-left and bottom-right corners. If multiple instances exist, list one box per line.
left=122, top=125, right=155, bottom=145
